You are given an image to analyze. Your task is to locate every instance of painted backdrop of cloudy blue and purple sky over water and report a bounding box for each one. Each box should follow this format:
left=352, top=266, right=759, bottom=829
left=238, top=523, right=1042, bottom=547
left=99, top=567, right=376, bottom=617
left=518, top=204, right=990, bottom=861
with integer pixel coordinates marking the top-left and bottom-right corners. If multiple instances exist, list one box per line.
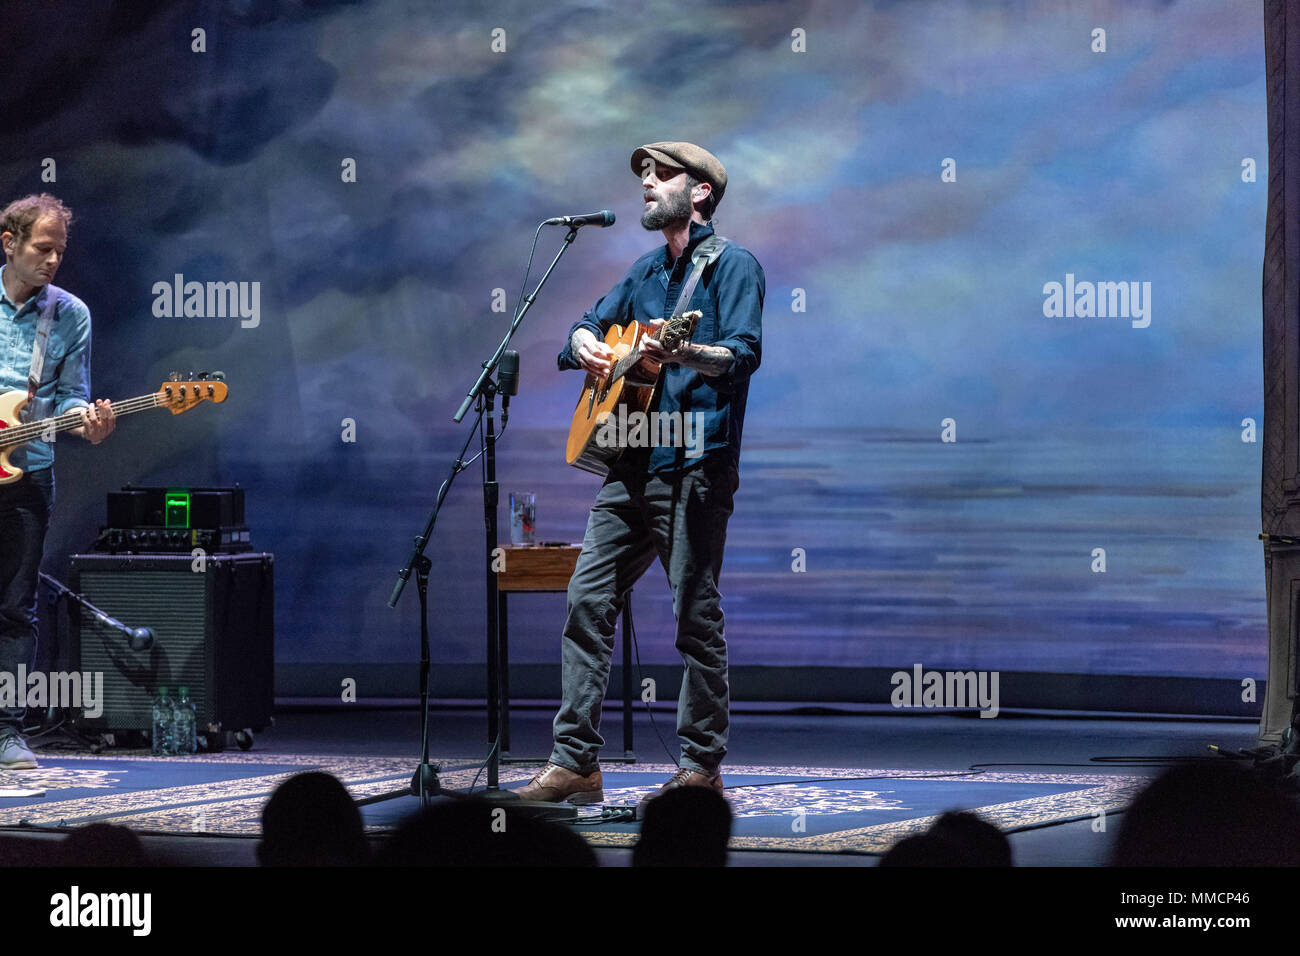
left=0, top=0, right=1266, bottom=679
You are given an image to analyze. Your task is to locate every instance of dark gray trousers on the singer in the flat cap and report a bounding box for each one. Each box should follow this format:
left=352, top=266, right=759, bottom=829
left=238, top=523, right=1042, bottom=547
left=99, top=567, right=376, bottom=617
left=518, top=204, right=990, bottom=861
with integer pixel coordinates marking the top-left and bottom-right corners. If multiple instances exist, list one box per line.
left=551, top=459, right=740, bottom=774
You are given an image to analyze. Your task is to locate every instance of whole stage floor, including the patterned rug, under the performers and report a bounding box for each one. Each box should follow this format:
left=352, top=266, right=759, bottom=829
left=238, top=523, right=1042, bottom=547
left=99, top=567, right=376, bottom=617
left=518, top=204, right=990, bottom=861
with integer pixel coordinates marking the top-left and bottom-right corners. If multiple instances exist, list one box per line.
left=0, top=701, right=1256, bottom=866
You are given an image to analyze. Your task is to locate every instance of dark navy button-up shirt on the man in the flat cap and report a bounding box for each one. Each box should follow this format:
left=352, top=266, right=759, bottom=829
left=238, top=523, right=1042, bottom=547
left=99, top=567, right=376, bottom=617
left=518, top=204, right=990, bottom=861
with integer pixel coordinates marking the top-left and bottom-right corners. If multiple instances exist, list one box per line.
left=558, top=222, right=766, bottom=473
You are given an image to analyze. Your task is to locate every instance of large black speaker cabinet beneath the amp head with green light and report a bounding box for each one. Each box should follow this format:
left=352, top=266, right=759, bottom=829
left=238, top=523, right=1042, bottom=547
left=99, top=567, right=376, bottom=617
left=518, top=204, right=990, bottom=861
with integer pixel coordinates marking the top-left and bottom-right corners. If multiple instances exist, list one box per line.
left=70, top=553, right=276, bottom=734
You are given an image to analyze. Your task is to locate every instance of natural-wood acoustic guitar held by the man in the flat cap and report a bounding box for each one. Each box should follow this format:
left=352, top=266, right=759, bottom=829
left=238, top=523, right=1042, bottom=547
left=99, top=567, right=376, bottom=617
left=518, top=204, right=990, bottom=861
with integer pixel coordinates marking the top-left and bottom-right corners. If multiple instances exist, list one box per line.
left=564, top=310, right=703, bottom=475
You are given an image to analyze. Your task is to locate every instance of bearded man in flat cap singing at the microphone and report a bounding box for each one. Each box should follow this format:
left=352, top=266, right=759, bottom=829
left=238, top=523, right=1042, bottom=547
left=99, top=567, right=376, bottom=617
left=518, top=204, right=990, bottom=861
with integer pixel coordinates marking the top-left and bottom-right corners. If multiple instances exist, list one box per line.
left=517, top=143, right=764, bottom=804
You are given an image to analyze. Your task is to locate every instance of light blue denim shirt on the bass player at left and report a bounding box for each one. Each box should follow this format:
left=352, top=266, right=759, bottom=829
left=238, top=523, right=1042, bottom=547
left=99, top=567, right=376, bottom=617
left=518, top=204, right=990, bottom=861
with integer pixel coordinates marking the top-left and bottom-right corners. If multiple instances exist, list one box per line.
left=0, top=265, right=90, bottom=471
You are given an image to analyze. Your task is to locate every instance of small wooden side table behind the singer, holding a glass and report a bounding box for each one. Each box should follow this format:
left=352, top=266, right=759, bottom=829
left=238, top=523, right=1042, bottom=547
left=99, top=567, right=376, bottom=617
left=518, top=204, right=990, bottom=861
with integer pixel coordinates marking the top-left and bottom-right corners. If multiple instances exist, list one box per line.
left=497, top=545, right=637, bottom=763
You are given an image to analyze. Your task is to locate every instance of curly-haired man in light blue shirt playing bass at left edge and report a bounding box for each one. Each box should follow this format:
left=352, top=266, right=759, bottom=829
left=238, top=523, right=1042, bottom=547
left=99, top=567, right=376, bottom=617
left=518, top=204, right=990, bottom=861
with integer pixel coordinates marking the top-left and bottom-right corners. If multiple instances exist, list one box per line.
left=0, top=194, right=116, bottom=770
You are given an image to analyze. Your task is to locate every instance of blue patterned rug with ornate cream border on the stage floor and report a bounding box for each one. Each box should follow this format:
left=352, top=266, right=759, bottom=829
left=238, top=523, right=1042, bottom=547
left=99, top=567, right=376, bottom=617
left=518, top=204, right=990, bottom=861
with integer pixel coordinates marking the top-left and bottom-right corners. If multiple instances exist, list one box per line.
left=0, top=753, right=1148, bottom=853
